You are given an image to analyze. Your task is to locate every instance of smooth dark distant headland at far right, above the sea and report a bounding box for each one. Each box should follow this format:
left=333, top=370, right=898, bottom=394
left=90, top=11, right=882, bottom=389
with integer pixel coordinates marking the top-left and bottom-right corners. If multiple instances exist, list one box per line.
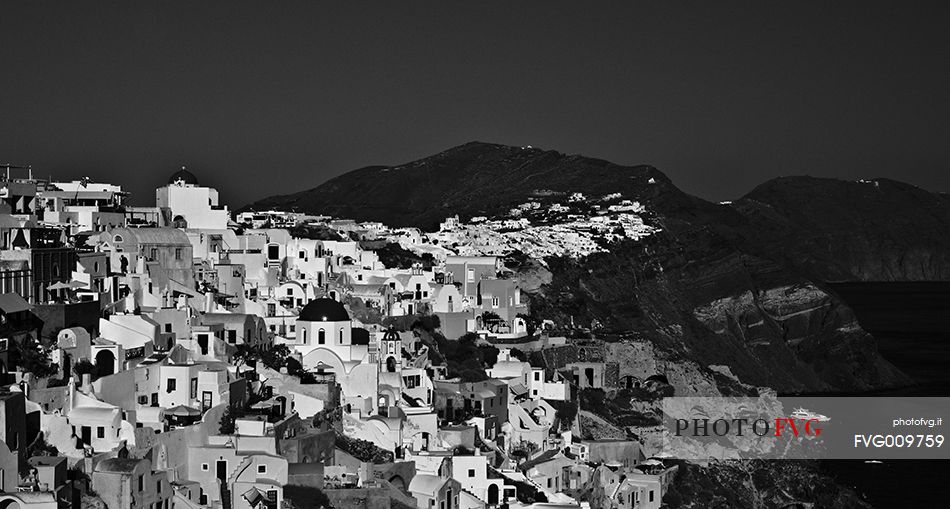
left=734, top=177, right=950, bottom=281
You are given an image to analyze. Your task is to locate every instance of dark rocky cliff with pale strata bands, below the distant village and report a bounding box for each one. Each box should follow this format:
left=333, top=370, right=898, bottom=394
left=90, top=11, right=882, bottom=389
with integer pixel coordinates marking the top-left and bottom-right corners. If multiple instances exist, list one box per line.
left=531, top=236, right=910, bottom=394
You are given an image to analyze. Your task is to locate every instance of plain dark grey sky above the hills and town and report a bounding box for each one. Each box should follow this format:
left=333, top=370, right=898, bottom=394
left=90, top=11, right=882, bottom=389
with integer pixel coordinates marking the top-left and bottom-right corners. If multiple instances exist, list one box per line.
left=0, top=0, right=950, bottom=208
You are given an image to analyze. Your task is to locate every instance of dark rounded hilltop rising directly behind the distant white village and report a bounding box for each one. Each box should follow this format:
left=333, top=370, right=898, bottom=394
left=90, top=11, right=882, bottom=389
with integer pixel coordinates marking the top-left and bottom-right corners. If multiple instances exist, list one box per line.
left=244, top=142, right=728, bottom=228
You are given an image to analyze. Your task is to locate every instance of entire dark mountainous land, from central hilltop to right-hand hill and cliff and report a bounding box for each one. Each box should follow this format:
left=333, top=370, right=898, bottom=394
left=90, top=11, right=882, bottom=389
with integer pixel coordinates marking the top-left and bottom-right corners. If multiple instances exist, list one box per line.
left=249, top=143, right=950, bottom=392
